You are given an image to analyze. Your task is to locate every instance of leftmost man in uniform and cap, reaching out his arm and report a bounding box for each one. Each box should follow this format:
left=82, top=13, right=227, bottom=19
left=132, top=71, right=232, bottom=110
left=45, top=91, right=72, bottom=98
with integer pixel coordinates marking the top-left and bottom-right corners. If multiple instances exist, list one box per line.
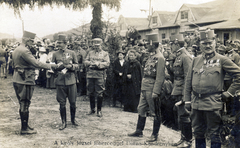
left=12, top=31, right=57, bottom=134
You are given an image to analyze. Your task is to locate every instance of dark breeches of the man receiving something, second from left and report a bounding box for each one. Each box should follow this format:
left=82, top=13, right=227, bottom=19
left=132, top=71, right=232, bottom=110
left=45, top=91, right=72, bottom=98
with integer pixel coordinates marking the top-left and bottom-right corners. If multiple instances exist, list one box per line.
left=56, top=84, right=77, bottom=108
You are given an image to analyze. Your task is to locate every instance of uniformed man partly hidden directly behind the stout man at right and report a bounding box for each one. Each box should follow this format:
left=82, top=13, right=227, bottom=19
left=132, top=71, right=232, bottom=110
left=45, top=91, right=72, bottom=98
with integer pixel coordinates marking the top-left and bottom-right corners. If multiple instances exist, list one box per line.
left=171, top=34, right=192, bottom=147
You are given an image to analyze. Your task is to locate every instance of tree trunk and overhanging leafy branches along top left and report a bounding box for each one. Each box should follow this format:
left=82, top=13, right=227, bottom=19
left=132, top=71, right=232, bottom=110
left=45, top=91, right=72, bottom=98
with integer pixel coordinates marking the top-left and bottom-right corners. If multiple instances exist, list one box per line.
left=0, top=0, right=121, bottom=38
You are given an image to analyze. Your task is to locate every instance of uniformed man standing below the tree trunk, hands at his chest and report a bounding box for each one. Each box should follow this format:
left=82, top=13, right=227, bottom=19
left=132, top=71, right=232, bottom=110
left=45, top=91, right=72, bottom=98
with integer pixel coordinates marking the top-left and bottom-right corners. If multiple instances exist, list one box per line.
left=85, top=38, right=110, bottom=117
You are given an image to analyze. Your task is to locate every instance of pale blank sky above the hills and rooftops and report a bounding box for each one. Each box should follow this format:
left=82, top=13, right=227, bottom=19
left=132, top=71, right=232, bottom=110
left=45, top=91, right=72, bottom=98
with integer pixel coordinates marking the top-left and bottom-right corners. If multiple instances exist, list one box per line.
left=0, top=0, right=213, bottom=38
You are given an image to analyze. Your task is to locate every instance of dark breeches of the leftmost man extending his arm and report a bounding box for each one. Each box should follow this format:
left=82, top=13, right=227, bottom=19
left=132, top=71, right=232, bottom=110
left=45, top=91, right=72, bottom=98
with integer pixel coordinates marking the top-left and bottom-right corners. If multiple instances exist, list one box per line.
left=13, top=83, right=34, bottom=112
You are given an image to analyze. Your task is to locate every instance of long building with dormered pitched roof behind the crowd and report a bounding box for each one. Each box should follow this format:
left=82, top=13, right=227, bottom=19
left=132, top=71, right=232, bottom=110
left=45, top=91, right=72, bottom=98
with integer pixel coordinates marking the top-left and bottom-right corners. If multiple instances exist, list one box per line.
left=117, top=0, right=240, bottom=43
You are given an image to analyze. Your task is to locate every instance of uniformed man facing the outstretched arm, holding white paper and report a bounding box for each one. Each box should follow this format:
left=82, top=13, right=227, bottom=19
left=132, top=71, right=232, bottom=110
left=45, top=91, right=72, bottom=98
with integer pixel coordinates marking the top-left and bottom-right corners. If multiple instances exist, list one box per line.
left=52, top=34, right=78, bottom=130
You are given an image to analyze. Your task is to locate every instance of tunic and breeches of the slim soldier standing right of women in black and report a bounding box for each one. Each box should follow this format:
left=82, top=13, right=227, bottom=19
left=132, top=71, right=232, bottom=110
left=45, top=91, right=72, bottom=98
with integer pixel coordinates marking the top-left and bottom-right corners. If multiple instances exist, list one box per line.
left=138, top=53, right=165, bottom=117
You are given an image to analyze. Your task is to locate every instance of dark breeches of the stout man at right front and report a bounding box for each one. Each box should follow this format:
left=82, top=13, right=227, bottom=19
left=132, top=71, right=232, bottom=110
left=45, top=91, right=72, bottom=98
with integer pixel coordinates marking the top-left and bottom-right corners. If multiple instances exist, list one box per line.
left=191, top=109, right=222, bottom=142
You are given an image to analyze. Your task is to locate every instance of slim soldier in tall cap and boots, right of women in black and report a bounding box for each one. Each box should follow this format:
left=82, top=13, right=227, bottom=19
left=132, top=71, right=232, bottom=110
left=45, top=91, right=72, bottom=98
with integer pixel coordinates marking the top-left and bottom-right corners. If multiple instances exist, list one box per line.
left=128, top=35, right=165, bottom=142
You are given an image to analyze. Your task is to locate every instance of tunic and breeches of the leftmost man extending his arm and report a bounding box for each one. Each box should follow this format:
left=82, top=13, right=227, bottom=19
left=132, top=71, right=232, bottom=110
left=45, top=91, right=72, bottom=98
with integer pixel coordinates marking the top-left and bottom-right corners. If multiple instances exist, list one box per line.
left=12, top=44, right=51, bottom=111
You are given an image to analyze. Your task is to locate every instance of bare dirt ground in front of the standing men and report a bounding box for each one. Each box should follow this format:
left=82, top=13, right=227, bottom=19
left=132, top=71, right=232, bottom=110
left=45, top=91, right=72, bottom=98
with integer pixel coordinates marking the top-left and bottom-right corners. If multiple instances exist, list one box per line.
left=0, top=76, right=180, bottom=148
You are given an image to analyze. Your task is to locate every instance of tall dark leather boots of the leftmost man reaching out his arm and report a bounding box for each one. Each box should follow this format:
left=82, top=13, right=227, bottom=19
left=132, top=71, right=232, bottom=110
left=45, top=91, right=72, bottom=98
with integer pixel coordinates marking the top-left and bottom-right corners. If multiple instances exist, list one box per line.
left=19, top=111, right=37, bottom=135
